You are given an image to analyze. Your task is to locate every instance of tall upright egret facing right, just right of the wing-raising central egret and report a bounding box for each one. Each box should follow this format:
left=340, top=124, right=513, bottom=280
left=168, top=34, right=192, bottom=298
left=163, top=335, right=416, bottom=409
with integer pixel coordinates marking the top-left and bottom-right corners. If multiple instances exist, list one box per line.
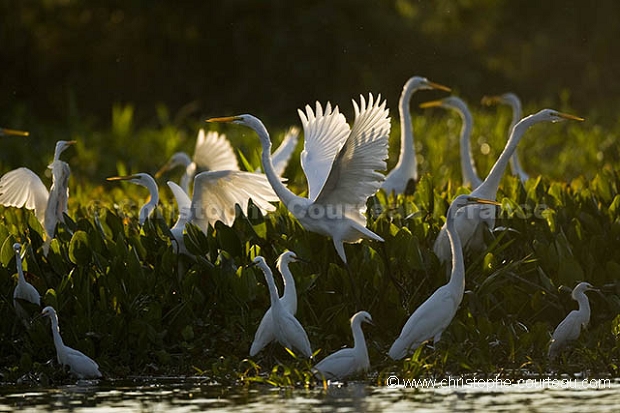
left=381, top=76, right=450, bottom=194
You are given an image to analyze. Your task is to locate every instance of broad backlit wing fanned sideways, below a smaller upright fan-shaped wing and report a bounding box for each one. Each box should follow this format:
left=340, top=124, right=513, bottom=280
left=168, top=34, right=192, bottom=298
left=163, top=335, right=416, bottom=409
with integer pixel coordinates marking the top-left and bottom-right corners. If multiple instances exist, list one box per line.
left=191, top=170, right=279, bottom=232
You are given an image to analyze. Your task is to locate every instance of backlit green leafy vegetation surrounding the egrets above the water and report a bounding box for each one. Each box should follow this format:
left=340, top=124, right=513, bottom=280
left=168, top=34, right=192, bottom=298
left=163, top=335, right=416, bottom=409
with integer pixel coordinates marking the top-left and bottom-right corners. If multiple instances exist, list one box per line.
left=0, top=103, right=620, bottom=386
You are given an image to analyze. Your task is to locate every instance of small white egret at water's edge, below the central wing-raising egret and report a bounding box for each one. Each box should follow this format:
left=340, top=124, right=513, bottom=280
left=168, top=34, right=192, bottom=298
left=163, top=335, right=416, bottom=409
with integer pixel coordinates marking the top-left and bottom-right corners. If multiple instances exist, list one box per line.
left=313, top=311, right=372, bottom=380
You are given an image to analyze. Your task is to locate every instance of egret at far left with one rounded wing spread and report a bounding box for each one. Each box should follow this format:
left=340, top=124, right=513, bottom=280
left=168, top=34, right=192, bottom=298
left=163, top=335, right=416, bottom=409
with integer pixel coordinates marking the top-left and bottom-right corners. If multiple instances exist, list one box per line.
left=0, top=141, right=75, bottom=238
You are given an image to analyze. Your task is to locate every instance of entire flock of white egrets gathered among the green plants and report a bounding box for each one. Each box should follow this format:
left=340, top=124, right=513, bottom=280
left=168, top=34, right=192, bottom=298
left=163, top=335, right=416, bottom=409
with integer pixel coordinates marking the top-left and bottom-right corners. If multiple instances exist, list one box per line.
left=0, top=76, right=592, bottom=379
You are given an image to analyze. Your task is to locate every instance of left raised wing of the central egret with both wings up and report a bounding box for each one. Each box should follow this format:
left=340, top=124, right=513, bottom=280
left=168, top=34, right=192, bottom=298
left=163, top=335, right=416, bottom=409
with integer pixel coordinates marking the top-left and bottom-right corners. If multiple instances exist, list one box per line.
left=297, top=102, right=350, bottom=201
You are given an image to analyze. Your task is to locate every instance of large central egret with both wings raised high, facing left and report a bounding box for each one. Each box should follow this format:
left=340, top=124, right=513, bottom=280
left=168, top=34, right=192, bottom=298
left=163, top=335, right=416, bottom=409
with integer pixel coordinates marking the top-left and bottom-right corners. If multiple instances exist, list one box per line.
left=207, top=95, right=390, bottom=263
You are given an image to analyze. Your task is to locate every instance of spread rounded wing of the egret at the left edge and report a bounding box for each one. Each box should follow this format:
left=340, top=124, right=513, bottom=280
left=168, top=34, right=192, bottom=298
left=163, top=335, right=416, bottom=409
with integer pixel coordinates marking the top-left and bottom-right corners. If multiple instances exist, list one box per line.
left=0, top=168, right=49, bottom=222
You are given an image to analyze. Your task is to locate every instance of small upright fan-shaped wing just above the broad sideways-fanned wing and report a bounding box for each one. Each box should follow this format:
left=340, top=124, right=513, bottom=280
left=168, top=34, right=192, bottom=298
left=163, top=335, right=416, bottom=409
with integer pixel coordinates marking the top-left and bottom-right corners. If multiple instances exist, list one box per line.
left=194, top=129, right=239, bottom=171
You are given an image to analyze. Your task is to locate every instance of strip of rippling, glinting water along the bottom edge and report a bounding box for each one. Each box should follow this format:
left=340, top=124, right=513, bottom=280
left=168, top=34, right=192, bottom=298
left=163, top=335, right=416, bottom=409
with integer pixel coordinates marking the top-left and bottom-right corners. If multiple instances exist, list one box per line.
left=0, top=378, right=620, bottom=413
